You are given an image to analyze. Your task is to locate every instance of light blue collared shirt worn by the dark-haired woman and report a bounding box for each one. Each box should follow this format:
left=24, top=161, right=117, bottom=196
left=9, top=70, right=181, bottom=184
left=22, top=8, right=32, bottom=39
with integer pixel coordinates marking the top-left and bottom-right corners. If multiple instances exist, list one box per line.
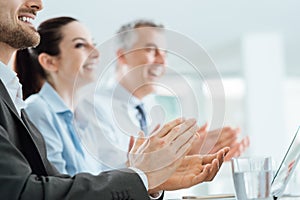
left=25, top=82, right=102, bottom=175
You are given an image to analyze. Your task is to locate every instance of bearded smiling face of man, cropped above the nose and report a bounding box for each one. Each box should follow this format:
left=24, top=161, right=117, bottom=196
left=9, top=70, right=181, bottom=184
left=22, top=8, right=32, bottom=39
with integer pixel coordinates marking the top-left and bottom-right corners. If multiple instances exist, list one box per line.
left=0, top=0, right=42, bottom=50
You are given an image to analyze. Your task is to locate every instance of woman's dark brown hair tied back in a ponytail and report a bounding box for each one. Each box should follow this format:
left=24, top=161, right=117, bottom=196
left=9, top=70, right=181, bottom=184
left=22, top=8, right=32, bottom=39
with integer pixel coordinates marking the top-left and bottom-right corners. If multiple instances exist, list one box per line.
left=14, top=17, right=78, bottom=99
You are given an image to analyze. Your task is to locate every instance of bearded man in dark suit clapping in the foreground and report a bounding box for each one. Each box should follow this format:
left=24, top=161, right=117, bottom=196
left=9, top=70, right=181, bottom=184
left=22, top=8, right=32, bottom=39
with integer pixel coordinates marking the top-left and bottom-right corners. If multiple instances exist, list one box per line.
left=0, top=0, right=228, bottom=200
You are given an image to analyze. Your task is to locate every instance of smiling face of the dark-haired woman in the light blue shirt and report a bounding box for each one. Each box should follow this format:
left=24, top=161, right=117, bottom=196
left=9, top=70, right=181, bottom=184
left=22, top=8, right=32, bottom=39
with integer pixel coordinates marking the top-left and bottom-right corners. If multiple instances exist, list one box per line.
left=50, top=21, right=99, bottom=87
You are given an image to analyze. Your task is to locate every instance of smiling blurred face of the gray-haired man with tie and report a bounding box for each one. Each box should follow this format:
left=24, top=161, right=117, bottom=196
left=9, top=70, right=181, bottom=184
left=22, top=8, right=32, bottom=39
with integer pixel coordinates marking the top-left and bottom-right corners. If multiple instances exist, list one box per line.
left=118, top=27, right=166, bottom=99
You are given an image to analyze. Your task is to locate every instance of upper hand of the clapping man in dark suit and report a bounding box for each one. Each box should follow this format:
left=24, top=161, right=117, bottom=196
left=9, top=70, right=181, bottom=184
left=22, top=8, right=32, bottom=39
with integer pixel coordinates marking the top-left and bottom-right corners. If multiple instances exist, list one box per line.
left=128, top=119, right=198, bottom=189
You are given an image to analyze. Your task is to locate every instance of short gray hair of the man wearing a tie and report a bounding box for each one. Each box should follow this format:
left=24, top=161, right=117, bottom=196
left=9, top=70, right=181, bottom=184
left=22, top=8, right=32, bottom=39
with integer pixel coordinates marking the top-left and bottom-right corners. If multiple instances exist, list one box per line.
left=117, top=19, right=164, bottom=50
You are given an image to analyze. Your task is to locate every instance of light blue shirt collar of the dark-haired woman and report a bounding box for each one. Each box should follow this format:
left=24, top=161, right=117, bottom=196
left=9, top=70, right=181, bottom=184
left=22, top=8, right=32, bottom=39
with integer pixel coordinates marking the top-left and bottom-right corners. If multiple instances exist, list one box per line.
left=39, top=82, right=71, bottom=113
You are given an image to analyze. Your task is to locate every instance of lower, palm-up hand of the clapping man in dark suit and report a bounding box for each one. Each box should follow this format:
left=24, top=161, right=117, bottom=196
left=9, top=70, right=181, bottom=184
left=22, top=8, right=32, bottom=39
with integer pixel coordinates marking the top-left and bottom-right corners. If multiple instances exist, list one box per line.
left=150, top=147, right=229, bottom=193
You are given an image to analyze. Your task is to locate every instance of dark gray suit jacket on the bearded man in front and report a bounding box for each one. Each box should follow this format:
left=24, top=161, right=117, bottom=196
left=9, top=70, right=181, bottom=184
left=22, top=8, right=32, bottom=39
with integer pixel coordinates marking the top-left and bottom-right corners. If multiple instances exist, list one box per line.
left=0, top=80, right=159, bottom=200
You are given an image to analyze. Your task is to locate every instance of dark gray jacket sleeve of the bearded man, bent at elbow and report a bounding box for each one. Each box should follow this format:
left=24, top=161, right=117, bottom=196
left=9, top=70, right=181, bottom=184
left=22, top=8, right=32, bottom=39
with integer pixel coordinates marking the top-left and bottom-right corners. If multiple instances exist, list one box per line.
left=0, top=127, right=149, bottom=200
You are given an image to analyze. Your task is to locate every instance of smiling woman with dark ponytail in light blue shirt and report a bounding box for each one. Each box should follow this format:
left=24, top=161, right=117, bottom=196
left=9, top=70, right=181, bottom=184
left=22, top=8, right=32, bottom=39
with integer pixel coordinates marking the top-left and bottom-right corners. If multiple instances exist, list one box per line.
left=14, top=17, right=101, bottom=175
